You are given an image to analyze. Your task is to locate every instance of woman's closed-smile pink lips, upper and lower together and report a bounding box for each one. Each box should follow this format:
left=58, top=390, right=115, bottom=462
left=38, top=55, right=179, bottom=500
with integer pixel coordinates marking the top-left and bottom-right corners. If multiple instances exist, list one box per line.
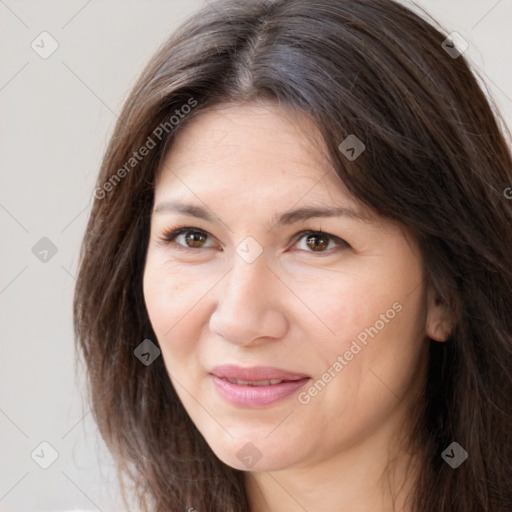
left=211, top=365, right=310, bottom=407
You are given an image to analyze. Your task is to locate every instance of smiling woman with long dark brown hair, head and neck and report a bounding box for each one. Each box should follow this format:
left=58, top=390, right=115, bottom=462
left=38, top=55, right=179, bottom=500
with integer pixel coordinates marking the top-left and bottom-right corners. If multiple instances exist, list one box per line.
left=74, top=0, right=512, bottom=512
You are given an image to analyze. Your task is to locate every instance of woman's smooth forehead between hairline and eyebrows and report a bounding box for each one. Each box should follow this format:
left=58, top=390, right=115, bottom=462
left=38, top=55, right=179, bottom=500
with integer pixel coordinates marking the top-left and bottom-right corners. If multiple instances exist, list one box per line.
left=155, top=104, right=357, bottom=205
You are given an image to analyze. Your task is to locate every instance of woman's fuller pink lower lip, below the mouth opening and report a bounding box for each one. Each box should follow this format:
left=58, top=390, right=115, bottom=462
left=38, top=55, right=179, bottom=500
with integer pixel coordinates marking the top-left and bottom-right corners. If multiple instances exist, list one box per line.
left=212, top=375, right=310, bottom=407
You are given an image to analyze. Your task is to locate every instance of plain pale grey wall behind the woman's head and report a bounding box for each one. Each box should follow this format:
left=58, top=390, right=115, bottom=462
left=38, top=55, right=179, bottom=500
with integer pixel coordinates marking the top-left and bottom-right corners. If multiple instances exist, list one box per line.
left=0, top=0, right=512, bottom=512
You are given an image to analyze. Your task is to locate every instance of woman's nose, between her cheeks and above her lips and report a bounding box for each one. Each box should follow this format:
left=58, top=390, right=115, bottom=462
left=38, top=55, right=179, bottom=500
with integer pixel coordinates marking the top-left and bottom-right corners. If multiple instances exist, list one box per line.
left=210, top=249, right=289, bottom=346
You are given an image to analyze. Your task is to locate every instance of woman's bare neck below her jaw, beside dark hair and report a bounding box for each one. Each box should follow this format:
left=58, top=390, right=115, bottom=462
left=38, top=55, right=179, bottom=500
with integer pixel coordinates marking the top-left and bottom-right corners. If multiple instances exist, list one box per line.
left=245, top=400, right=420, bottom=512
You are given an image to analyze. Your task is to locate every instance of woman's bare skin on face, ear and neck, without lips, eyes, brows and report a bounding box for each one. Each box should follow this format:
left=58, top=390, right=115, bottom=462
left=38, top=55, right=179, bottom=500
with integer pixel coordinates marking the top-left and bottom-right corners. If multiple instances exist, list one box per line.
left=144, top=104, right=449, bottom=512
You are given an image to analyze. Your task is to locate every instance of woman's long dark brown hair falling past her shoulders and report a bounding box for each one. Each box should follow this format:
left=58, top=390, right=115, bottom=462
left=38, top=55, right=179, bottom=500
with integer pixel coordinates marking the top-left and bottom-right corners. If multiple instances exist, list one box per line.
left=74, top=0, right=512, bottom=512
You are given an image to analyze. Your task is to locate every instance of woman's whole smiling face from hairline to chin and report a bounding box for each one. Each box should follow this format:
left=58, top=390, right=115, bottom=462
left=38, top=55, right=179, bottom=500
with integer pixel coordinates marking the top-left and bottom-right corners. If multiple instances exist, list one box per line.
left=144, top=105, right=446, bottom=470
